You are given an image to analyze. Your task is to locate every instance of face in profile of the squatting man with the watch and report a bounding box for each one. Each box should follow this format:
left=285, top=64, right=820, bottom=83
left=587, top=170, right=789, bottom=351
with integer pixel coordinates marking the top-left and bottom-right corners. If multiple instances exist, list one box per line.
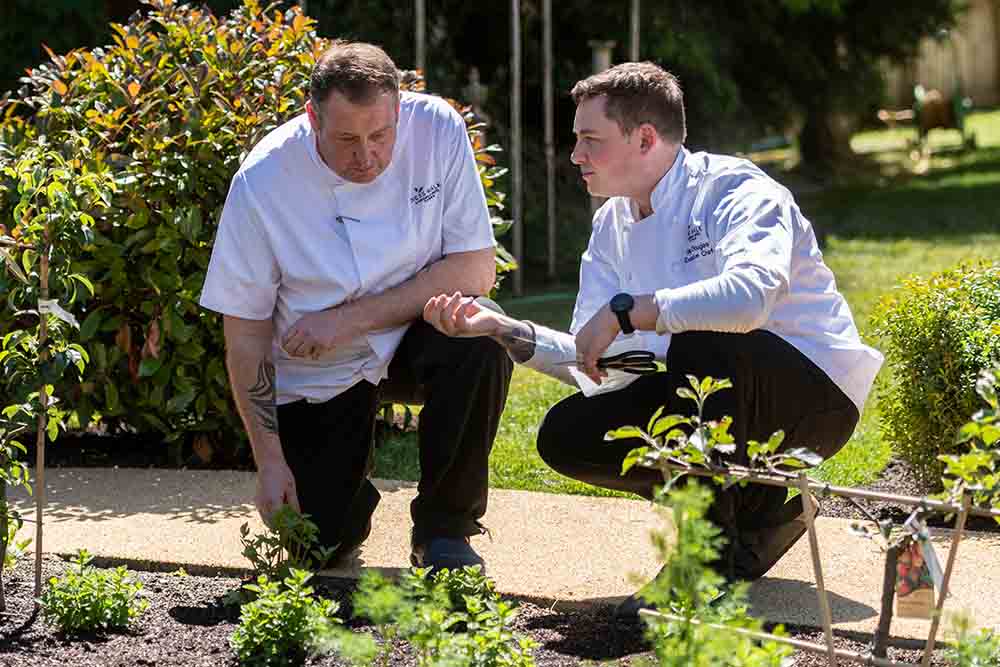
left=569, top=95, right=640, bottom=197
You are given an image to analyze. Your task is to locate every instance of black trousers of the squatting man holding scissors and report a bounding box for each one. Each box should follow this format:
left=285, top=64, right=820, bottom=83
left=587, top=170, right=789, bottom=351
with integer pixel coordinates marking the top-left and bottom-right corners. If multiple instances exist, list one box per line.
left=538, top=330, right=858, bottom=543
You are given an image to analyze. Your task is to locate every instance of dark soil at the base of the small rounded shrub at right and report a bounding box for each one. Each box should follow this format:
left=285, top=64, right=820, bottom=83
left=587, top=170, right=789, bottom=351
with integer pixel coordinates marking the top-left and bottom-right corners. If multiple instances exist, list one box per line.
left=820, top=459, right=1000, bottom=532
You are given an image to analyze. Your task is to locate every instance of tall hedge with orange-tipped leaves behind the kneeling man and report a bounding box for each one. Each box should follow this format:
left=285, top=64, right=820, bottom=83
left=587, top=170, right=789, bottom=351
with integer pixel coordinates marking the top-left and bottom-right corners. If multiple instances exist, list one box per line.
left=0, top=0, right=514, bottom=454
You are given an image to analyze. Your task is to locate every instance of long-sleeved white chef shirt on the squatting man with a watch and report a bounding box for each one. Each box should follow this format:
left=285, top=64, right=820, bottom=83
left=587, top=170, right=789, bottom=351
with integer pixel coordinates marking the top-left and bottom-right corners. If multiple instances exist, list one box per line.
left=570, top=147, right=883, bottom=411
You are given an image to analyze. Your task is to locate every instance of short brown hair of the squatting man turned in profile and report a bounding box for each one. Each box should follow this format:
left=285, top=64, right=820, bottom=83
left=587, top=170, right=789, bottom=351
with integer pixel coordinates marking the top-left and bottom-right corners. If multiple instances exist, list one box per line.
left=570, top=62, right=687, bottom=143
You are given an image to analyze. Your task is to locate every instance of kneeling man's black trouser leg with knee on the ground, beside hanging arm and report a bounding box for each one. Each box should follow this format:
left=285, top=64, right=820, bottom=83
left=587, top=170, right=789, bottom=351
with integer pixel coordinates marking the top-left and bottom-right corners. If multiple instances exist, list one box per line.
left=278, top=380, right=380, bottom=554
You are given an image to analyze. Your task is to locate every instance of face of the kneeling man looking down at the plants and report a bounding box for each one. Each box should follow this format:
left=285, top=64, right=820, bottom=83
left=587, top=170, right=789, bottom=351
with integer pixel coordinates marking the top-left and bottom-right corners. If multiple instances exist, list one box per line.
left=306, top=91, right=399, bottom=183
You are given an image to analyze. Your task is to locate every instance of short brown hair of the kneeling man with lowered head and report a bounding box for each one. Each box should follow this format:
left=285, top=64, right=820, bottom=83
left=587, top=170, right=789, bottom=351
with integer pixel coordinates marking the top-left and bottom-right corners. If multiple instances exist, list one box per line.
left=309, top=39, right=399, bottom=107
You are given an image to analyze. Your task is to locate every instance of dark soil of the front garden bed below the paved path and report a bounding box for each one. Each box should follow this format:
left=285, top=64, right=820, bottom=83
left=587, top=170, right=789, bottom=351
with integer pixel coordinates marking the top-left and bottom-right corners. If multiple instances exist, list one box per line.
left=0, top=557, right=945, bottom=667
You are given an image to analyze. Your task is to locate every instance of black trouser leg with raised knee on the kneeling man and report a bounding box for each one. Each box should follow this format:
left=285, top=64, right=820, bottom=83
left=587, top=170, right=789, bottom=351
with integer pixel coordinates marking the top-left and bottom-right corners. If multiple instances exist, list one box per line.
left=389, top=320, right=513, bottom=543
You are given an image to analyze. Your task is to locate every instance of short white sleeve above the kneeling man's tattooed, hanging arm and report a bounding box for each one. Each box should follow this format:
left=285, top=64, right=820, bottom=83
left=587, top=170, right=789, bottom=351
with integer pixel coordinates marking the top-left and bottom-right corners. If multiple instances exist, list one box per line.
left=200, top=173, right=281, bottom=320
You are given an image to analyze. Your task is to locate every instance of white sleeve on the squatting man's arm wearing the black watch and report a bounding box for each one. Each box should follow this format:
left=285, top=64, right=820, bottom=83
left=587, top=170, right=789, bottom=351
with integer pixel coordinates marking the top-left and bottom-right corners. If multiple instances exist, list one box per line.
left=656, top=179, right=793, bottom=334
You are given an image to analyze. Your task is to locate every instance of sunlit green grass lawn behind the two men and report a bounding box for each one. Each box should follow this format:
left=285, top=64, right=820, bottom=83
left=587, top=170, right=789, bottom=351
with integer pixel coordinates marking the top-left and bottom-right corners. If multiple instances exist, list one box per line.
left=376, top=111, right=1000, bottom=495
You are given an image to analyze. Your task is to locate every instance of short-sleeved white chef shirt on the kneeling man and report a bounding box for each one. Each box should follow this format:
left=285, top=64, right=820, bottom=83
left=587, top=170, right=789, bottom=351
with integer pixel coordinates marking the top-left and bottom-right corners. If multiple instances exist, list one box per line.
left=201, top=92, right=494, bottom=405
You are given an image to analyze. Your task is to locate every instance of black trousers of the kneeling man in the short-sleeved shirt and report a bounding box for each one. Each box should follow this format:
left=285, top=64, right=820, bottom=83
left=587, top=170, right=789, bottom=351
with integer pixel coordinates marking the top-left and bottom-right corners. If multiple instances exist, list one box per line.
left=278, top=320, right=513, bottom=552
